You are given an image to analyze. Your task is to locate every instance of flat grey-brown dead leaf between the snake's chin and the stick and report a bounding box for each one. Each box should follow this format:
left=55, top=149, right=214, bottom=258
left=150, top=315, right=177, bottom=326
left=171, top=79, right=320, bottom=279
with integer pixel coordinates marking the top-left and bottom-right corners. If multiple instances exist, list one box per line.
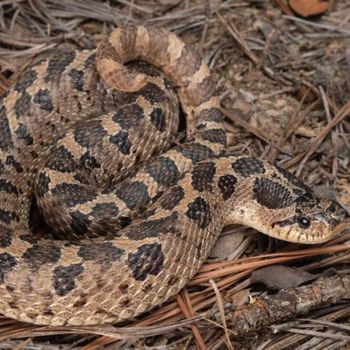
left=251, top=265, right=317, bottom=289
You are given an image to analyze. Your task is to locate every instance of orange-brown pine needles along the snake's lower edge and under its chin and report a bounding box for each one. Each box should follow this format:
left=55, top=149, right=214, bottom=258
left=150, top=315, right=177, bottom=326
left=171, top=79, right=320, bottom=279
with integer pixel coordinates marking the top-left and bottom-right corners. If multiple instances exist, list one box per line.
left=0, top=237, right=350, bottom=350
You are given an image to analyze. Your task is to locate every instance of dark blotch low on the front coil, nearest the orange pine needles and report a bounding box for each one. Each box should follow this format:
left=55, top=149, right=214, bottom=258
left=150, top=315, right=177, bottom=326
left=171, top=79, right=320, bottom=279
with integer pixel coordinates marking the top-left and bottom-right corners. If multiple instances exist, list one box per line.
left=128, top=243, right=164, bottom=281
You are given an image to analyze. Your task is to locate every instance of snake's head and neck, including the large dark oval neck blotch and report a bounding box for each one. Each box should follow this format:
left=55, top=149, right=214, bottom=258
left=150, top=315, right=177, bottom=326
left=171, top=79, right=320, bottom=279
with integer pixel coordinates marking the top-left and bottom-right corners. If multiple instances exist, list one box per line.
left=226, top=158, right=350, bottom=244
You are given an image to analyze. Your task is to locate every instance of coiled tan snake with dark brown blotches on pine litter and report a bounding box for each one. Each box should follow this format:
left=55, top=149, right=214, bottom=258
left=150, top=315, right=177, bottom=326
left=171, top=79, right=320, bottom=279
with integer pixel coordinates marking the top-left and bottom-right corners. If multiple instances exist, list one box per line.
left=0, top=25, right=349, bottom=326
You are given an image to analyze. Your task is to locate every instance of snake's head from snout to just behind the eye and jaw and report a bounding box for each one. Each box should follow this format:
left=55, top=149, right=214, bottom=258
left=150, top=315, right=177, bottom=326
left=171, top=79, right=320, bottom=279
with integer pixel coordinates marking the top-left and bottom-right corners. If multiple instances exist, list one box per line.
left=272, top=192, right=350, bottom=244
